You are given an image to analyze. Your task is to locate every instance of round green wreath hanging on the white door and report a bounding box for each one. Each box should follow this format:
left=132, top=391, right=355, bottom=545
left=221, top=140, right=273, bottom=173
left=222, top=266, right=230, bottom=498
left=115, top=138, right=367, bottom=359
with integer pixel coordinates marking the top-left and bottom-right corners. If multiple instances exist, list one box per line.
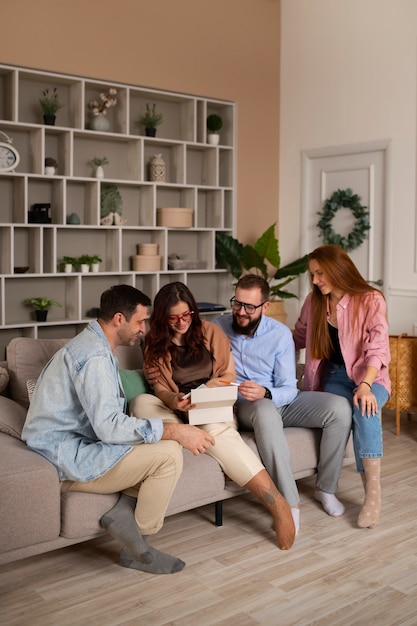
left=317, top=189, right=371, bottom=252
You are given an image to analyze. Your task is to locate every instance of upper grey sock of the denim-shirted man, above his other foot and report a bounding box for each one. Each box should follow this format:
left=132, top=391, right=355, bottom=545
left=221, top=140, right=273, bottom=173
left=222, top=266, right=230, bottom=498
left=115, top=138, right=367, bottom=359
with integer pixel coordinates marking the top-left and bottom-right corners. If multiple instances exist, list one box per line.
left=100, top=494, right=154, bottom=563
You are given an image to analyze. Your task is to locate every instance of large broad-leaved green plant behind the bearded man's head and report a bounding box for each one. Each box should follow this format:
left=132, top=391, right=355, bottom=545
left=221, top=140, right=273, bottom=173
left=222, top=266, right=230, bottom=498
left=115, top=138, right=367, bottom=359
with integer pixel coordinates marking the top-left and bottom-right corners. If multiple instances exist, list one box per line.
left=216, top=223, right=308, bottom=299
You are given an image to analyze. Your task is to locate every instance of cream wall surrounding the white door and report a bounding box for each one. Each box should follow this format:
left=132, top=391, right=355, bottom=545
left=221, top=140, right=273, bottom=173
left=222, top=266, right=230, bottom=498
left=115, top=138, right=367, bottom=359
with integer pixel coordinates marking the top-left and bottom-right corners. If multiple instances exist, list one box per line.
left=280, top=0, right=417, bottom=334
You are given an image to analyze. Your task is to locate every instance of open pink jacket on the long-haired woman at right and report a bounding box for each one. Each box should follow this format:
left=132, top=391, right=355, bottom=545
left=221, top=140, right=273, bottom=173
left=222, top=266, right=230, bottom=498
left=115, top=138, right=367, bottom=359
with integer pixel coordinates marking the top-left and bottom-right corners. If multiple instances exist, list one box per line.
left=294, top=292, right=391, bottom=393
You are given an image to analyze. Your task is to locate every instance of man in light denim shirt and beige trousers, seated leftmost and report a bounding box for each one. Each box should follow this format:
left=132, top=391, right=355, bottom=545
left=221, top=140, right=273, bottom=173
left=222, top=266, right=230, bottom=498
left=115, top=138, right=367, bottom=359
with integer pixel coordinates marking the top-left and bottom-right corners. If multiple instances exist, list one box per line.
left=22, top=285, right=214, bottom=574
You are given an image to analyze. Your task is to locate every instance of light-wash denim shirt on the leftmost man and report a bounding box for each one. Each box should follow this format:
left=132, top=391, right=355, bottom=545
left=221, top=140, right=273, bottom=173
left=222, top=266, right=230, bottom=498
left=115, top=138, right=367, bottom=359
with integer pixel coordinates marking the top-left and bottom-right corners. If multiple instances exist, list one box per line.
left=22, top=321, right=163, bottom=482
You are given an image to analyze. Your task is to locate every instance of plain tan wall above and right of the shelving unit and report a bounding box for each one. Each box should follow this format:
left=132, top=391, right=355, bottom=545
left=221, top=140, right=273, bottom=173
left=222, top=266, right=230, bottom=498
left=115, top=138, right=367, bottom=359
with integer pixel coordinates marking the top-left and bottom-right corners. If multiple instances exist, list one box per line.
left=0, top=0, right=280, bottom=241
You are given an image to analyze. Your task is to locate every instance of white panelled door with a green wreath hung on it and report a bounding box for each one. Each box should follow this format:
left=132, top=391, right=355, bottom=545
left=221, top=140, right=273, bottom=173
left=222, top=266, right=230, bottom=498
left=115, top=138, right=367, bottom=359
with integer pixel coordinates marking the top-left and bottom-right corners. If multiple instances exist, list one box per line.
left=301, top=141, right=389, bottom=301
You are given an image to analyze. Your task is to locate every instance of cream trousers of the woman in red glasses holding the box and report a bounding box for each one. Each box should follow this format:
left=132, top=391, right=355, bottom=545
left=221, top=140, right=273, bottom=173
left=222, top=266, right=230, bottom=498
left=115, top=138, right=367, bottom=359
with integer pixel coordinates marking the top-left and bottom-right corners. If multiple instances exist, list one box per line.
left=130, top=393, right=265, bottom=487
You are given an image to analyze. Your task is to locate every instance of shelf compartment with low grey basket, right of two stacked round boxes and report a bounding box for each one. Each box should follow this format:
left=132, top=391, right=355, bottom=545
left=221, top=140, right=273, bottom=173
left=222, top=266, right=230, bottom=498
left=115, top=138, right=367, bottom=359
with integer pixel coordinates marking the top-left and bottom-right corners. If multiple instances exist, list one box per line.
left=168, top=229, right=214, bottom=271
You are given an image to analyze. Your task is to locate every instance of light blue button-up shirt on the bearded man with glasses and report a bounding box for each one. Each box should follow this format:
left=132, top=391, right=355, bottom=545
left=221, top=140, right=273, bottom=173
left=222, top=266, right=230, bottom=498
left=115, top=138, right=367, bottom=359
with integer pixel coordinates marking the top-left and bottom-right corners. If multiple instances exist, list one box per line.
left=214, top=315, right=298, bottom=407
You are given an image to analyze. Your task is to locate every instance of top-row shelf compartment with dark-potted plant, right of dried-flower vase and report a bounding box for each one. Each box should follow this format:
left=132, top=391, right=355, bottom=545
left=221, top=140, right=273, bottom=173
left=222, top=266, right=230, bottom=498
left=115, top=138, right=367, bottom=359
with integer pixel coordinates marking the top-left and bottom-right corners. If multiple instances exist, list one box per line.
left=129, top=89, right=195, bottom=141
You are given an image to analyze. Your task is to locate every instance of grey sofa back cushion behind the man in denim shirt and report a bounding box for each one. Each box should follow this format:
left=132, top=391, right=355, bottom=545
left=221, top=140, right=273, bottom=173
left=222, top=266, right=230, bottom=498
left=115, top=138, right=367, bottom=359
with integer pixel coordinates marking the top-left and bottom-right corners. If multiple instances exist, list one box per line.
left=7, top=337, right=69, bottom=409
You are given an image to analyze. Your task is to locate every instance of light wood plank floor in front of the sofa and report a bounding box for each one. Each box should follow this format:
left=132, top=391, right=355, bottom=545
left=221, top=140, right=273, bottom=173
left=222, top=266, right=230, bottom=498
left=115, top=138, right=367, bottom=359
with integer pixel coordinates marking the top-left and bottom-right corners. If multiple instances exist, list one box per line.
left=0, top=411, right=417, bottom=626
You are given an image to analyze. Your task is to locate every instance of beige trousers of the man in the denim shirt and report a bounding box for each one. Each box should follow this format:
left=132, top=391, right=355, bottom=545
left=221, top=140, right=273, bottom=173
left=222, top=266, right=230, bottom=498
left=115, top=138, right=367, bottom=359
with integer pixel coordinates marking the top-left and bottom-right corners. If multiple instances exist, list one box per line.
left=61, top=441, right=183, bottom=535
